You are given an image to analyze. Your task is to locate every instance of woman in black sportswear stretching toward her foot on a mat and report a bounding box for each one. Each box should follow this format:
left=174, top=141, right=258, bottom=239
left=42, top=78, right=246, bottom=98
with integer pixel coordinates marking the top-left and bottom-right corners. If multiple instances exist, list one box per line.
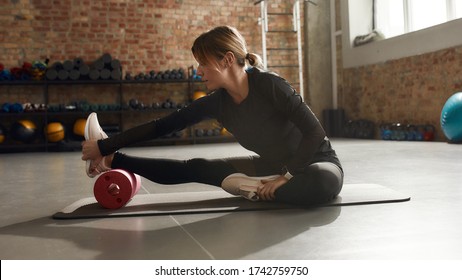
left=82, top=26, right=343, bottom=206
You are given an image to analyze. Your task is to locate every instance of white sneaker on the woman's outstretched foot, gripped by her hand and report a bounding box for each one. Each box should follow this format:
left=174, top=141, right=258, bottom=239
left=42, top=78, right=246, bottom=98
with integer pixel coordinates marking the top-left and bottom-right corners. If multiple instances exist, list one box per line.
left=84, top=112, right=111, bottom=178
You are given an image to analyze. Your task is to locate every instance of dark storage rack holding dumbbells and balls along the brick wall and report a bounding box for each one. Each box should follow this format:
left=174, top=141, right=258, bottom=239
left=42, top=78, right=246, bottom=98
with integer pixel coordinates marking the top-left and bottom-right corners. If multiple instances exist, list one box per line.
left=0, top=74, right=234, bottom=153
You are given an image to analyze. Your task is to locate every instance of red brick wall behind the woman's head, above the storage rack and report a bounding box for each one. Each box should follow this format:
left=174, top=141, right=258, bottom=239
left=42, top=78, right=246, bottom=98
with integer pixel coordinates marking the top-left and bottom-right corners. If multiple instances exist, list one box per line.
left=0, top=0, right=261, bottom=72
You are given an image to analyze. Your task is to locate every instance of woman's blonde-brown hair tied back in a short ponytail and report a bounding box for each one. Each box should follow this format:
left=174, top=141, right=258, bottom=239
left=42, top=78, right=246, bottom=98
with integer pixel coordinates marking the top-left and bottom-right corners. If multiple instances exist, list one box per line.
left=191, top=26, right=263, bottom=68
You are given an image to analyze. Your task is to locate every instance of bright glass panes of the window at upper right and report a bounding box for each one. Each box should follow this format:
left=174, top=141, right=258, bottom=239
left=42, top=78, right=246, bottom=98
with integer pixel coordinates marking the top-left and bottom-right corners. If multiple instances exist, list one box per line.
left=374, top=0, right=462, bottom=38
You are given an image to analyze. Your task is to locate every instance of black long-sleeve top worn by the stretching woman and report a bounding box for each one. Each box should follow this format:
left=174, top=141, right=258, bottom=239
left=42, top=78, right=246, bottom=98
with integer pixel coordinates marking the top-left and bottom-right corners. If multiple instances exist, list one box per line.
left=98, top=68, right=341, bottom=174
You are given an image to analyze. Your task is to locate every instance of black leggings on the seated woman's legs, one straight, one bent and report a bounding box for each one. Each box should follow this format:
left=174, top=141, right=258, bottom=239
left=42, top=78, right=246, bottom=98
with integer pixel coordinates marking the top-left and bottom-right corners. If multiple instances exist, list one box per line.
left=111, top=152, right=343, bottom=206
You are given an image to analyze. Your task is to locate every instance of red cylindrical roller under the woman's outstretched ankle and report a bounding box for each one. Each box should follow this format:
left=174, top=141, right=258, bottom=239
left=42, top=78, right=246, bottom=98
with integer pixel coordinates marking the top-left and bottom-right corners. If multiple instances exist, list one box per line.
left=93, top=169, right=141, bottom=209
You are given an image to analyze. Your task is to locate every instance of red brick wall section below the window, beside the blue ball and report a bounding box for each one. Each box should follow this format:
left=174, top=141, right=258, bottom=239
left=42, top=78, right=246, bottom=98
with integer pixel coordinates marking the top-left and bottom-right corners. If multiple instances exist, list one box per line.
left=339, top=47, right=462, bottom=141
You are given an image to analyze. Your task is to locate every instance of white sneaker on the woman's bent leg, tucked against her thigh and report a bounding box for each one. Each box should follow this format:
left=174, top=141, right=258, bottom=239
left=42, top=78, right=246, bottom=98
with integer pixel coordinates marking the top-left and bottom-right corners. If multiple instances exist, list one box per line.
left=221, top=173, right=280, bottom=201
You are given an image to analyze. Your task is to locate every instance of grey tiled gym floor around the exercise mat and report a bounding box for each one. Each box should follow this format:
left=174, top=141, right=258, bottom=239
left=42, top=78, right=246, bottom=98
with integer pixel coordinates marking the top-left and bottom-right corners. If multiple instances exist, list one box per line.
left=0, top=139, right=462, bottom=260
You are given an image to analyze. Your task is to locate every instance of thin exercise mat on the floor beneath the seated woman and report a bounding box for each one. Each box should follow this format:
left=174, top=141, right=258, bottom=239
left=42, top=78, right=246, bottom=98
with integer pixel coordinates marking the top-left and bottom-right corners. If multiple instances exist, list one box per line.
left=53, top=184, right=410, bottom=219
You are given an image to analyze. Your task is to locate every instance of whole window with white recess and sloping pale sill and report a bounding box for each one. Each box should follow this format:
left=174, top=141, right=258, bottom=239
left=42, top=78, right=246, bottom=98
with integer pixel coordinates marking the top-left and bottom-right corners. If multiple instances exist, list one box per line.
left=342, top=0, right=462, bottom=68
